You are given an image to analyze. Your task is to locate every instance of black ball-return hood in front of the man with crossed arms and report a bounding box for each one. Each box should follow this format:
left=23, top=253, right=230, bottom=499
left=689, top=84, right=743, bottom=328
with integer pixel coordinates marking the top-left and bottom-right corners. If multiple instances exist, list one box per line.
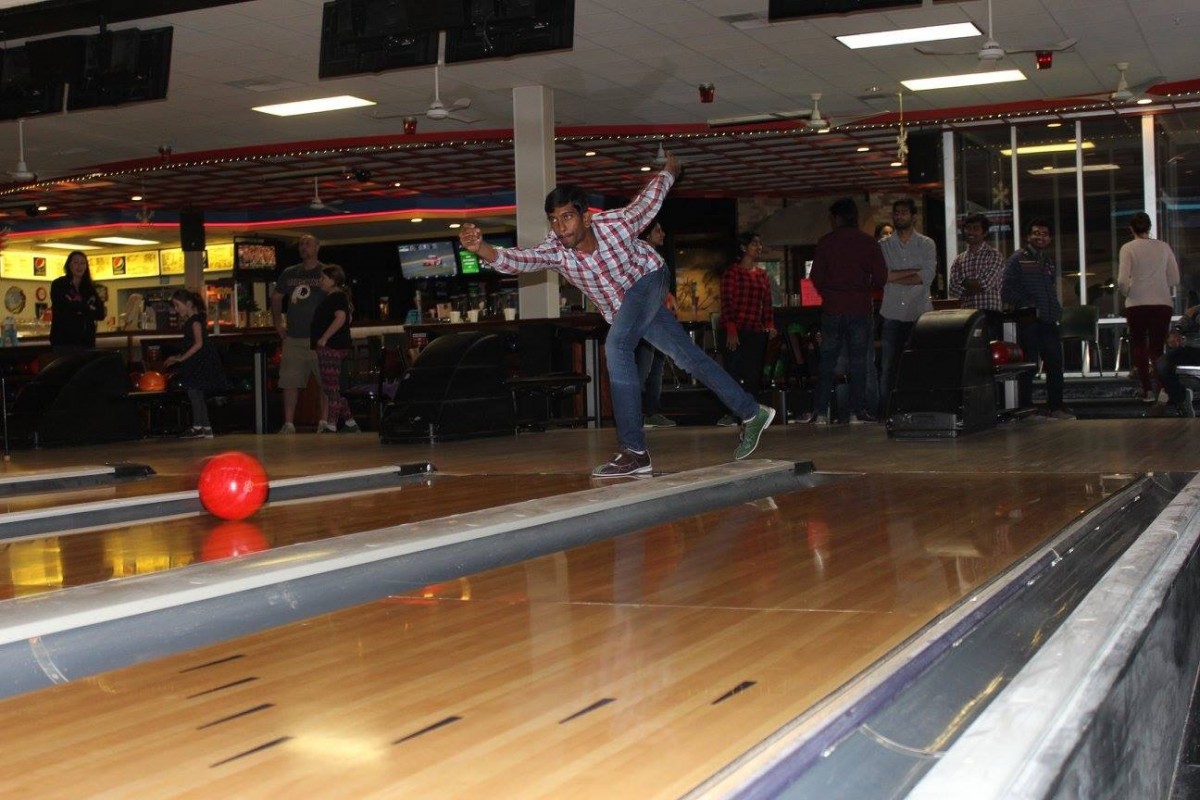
left=887, top=308, right=996, bottom=439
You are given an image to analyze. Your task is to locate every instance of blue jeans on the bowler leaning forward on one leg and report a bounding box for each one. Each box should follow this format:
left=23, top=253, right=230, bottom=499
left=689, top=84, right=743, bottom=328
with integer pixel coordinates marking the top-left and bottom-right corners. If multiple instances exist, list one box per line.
left=604, top=270, right=758, bottom=451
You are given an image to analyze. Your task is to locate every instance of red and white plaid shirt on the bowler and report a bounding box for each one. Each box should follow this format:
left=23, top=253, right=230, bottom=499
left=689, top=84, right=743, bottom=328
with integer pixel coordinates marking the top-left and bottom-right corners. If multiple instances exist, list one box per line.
left=485, top=172, right=674, bottom=323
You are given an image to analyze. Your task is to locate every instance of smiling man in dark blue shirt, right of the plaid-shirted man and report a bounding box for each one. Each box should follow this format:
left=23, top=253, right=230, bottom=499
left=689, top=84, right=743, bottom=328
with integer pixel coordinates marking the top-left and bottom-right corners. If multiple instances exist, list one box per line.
left=1001, top=217, right=1075, bottom=420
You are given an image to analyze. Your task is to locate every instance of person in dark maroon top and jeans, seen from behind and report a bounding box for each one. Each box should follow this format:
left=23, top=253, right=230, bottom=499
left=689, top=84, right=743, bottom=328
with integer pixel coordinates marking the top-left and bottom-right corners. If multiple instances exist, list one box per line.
left=810, top=197, right=888, bottom=423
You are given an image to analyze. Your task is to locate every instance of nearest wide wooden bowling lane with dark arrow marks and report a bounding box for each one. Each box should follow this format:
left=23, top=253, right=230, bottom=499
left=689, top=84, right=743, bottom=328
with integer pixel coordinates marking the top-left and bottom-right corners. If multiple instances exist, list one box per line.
left=0, top=474, right=1123, bottom=798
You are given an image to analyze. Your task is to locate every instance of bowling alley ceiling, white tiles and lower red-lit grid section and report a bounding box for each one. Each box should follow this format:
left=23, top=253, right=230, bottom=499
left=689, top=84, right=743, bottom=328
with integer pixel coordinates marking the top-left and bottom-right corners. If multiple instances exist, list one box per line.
left=0, top=0, right=1200, bottom=247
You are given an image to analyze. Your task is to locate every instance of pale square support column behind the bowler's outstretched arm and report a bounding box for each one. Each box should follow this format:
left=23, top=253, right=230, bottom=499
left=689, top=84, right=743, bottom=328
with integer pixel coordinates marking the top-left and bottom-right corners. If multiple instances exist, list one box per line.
left=512, top=86, right=558, bottom=319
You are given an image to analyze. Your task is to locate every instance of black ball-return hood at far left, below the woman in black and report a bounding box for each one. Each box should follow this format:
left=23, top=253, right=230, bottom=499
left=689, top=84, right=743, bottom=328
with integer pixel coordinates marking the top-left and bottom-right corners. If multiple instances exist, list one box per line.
left=8, top=350, right=142, bottom=447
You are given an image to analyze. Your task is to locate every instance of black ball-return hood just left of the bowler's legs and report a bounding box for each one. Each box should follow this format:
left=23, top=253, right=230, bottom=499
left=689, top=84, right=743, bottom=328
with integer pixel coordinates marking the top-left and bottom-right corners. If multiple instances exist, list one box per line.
left=379, top=331, right=516, bottom=443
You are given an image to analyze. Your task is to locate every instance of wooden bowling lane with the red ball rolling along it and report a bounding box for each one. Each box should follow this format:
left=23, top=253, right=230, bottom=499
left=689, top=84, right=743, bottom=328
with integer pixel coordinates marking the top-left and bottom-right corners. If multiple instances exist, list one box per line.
left=0, top=474, right=590, bottom=599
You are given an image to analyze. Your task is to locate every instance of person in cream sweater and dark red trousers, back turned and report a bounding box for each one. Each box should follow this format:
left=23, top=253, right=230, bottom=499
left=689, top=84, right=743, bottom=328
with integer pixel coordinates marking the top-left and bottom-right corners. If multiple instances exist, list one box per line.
left=1117, top=211, right=1180, bottom=403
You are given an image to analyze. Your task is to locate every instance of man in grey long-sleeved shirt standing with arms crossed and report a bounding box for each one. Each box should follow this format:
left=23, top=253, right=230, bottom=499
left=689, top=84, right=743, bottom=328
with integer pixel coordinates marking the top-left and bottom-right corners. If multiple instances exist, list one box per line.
left=880, top=198, right=937, bottom=415
